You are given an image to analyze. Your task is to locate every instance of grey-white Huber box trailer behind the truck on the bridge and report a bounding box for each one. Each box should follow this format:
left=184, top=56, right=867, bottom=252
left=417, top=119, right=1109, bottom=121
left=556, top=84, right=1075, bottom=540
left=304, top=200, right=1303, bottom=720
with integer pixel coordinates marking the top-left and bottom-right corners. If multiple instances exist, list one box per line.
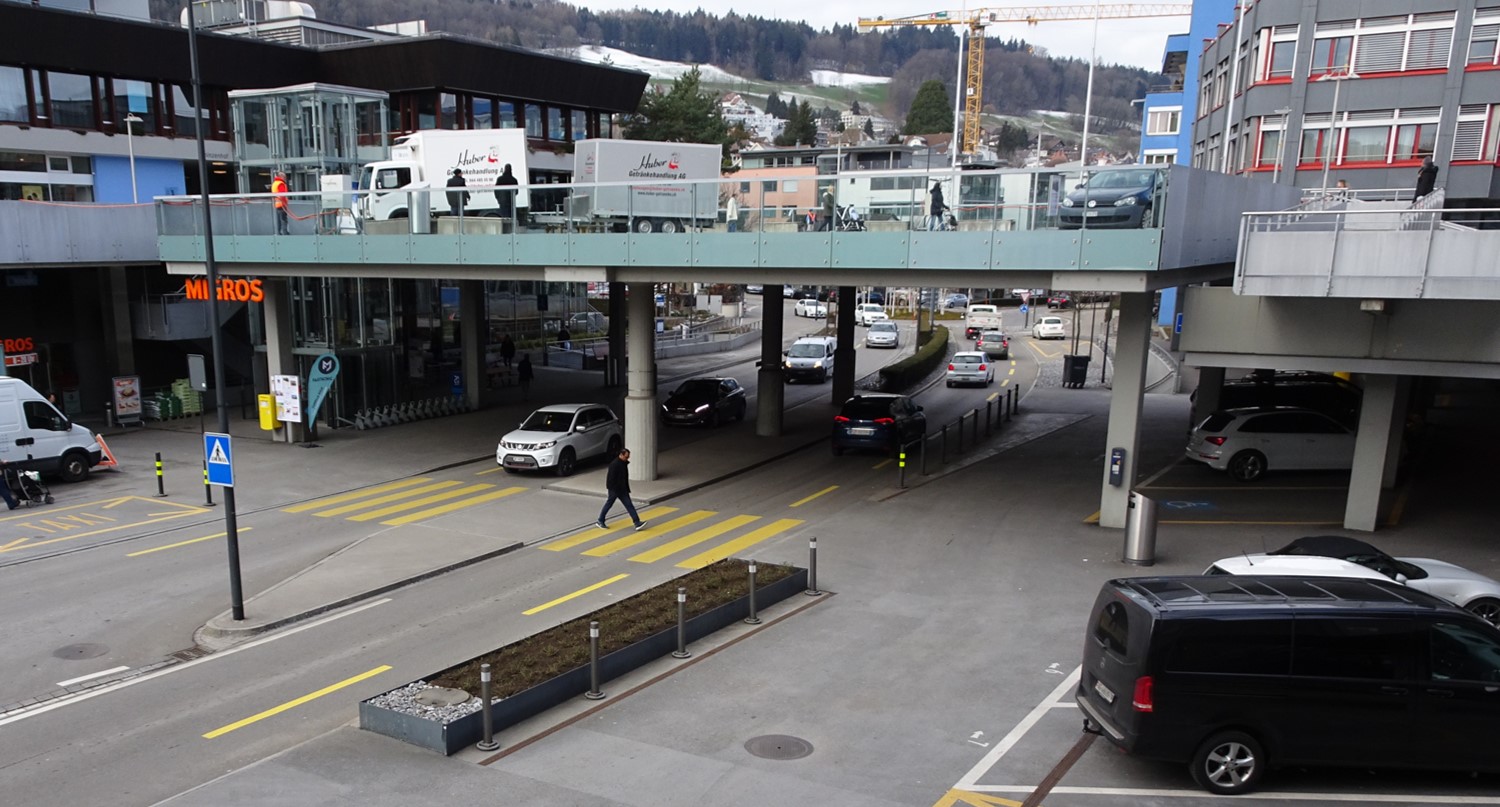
left=569, top=140, right=723, bottom=233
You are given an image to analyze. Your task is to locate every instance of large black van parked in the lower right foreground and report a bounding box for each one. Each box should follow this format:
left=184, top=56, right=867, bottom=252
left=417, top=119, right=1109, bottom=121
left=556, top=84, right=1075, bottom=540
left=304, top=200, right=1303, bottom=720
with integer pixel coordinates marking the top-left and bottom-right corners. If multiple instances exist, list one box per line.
left=1076, top=576, right=1500, bottom=795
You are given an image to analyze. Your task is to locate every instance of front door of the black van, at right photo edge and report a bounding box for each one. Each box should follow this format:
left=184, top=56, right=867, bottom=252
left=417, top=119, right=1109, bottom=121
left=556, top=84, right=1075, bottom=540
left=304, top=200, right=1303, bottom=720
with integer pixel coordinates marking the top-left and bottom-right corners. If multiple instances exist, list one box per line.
left=1412, top=620, right=1500, bottom=771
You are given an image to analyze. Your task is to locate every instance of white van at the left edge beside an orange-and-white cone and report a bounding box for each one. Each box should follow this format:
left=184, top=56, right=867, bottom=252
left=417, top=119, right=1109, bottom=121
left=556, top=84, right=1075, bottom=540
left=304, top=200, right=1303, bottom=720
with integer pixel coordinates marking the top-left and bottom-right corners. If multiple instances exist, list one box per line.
left=0, top=377, right=101, bottom=482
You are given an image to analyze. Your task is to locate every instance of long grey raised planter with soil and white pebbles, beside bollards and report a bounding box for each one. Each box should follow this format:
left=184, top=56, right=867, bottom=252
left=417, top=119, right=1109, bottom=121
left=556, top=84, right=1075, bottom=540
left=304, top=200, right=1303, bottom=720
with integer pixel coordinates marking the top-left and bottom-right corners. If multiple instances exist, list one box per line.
left=360, top=558, right=807, bottom=756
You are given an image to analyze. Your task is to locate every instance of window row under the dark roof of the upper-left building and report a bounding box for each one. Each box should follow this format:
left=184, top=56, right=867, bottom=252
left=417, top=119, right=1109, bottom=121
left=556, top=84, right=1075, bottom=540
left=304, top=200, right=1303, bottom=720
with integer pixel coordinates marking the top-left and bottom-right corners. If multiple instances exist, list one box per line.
left=0, top=65, right=230, bottom=140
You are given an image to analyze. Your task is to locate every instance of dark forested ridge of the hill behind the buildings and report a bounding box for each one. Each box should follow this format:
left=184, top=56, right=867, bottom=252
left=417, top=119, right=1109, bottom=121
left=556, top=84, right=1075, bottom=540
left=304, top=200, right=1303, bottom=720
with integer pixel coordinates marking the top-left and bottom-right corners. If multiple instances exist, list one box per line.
left=152, top=0, right=1160, bottom=122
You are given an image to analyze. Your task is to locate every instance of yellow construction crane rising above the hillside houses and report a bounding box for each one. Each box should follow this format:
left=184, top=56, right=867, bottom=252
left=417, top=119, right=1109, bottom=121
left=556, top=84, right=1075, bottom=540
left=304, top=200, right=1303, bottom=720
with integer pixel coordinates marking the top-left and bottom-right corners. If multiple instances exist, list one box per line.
left=860, top=3, right=1193, bottom=155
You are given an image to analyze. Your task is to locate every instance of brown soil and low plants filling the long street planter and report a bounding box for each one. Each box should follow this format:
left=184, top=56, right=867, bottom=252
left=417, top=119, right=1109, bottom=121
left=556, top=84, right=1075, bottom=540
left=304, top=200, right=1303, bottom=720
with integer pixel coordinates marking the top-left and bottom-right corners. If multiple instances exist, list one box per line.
left=431, top=558, right=795, bottom=698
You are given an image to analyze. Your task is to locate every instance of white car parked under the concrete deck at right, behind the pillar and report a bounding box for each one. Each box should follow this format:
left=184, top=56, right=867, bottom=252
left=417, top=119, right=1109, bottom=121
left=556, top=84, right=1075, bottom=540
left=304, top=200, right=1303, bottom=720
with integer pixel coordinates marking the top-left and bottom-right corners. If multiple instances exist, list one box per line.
left=1187, top=407, right=1355, bottom=482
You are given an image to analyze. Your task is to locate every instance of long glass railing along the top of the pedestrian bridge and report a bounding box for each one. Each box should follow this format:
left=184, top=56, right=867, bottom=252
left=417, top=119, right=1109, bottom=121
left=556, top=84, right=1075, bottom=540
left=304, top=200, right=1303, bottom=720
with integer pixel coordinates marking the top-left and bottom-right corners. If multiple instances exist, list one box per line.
left=156, top=165, right=1169, bottom=237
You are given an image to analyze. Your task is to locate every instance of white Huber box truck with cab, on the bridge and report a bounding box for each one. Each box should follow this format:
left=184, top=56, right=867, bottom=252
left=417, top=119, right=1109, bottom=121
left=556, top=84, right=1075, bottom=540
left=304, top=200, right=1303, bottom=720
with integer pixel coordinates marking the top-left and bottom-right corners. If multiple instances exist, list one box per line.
left=359, top=129, right=531, bottom=221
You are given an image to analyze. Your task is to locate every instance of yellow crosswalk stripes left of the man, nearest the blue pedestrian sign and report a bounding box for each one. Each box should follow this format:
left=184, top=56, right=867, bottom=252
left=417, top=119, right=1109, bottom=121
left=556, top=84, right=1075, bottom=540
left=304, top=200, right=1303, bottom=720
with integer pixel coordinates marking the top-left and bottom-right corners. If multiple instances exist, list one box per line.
left=282, top=477, right=525, bottom=527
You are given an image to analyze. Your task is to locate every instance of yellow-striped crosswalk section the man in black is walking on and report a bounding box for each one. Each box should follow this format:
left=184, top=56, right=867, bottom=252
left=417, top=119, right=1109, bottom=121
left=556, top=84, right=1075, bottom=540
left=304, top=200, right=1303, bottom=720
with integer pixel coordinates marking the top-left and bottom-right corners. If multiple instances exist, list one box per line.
left=542, top=507, right=803, bottom=569
